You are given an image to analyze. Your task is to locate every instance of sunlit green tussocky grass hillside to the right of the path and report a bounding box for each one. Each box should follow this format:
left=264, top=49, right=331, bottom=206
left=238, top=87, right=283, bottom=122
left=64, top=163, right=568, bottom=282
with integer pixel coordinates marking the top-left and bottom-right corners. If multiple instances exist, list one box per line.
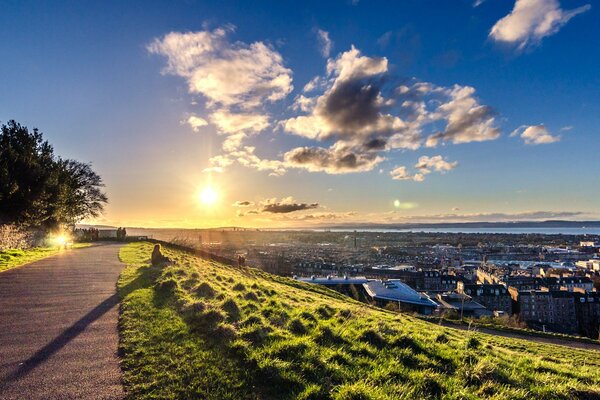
left=118, top=243, right=600, bottom=400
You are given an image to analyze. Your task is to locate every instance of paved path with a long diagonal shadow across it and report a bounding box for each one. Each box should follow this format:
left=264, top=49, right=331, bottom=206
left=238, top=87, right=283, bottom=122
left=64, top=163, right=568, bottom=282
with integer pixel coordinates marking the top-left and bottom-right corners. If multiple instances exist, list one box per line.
left=0, top=244, right=123, bottom=400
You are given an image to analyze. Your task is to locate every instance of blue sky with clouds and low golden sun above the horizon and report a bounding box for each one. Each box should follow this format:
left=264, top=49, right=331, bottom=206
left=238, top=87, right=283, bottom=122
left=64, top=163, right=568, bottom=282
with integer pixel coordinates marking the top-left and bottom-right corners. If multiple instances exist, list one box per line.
left=0, top=0, right=600, bottom=228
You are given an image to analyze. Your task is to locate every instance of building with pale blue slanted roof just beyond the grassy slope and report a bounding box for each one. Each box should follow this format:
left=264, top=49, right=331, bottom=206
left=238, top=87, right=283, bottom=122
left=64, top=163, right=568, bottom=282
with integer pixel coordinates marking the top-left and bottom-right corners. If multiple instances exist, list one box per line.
left=363, top=279, right=438, bottom=314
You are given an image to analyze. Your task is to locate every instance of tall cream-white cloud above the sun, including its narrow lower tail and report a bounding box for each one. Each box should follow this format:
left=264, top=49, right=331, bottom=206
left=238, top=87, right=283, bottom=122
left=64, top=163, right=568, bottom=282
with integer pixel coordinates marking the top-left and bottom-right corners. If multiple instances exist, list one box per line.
left=147, top=26, right=293, bottom=174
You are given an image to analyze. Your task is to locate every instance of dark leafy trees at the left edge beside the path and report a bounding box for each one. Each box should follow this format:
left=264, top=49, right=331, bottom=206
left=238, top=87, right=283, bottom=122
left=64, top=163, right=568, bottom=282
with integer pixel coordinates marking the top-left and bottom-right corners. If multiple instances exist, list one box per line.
left=0, top=120, right=108, bottom=229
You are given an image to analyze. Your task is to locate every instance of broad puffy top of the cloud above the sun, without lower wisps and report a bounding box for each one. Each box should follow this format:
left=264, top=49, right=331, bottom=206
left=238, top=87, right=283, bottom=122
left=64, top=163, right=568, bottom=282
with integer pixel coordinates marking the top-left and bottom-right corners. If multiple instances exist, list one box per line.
left=148, top=27, right=293, bottom=108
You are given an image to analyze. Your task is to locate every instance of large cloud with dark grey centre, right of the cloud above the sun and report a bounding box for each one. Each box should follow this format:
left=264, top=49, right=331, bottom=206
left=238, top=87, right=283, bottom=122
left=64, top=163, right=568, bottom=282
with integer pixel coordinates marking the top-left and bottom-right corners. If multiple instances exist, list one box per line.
left=280, top=47, right=500, bottom=173
